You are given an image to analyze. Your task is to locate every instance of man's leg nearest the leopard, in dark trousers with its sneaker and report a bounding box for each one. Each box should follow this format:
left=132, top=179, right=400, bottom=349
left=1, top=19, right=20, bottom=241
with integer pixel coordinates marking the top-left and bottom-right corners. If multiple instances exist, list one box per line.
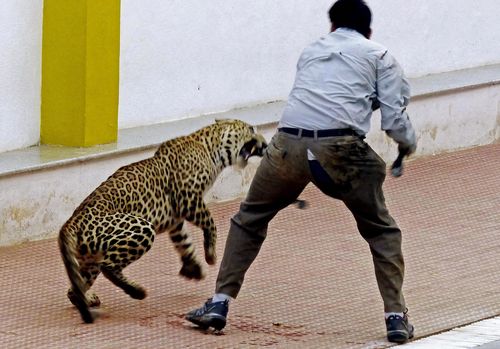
left=186, top=133, right=310, bottom=328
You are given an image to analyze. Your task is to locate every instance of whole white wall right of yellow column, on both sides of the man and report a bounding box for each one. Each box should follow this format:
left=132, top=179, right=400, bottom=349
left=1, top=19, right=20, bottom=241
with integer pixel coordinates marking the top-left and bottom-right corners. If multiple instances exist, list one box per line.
left=119, top=0, right=500, bottom=128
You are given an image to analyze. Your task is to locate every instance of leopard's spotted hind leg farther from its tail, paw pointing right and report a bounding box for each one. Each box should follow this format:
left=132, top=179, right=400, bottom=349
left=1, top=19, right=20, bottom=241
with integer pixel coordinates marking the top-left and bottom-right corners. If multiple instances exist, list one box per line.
left=100, top=214, right=155, bottom=299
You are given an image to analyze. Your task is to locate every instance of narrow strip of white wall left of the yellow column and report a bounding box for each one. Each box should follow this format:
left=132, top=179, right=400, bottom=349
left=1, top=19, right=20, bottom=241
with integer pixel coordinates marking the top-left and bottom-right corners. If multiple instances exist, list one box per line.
left=0, top=0, right=43, bottom=153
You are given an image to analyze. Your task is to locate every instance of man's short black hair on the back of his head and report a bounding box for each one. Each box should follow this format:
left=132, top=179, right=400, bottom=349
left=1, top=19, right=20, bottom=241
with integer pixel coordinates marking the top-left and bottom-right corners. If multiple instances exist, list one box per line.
left=328, top=0, right=372, bottom=38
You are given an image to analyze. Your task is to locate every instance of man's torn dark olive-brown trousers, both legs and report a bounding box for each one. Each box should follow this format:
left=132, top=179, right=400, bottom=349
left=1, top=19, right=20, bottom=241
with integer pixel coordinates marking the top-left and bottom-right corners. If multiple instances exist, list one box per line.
left=216, top=132, right=406, bottom=312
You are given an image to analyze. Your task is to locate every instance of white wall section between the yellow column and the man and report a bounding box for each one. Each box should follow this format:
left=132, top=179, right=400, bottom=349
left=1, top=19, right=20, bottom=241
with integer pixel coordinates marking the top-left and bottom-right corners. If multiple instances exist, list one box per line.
left=119, top=0, right=330, bottom=128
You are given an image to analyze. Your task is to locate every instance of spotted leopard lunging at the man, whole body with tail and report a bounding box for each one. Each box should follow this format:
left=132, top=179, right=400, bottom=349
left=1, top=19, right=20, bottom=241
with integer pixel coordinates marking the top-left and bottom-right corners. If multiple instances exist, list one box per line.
left=58, top=119, right=267, bottom=323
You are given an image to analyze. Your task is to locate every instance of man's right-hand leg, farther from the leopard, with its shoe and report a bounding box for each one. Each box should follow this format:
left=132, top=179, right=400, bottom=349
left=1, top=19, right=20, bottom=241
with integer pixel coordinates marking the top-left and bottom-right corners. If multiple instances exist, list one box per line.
left=311, top=140, right=413, bottom=342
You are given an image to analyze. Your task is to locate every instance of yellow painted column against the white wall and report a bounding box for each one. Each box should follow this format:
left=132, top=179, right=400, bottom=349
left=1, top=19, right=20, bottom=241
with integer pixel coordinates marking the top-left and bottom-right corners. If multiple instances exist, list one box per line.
left=41, top=0, right=120, bottom=147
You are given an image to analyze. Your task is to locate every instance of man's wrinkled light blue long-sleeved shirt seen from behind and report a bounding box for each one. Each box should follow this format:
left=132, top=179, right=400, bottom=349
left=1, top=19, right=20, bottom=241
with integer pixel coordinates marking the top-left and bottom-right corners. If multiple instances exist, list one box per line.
left=279, top=28, right=416, bottom=146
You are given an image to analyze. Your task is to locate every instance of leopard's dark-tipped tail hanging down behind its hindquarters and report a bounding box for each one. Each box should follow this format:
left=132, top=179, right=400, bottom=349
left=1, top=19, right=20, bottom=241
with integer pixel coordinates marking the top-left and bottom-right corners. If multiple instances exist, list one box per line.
left=59, top=225, right=94, bottom=323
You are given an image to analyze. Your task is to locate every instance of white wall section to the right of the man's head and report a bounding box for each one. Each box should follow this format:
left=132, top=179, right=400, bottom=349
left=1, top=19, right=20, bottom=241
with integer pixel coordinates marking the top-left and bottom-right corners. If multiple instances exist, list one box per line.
left=368, top=0, right=500, bottom=77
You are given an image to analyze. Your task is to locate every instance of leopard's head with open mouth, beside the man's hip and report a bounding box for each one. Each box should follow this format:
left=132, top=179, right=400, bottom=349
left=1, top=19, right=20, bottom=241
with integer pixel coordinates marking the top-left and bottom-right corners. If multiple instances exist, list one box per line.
left=216, top=119, right=267, bottom=168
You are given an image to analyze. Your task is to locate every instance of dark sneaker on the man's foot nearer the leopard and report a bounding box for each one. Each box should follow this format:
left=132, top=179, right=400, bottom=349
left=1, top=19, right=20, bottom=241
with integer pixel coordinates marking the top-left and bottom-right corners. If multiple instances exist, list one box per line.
left=186, top=298, right=229, bottom=331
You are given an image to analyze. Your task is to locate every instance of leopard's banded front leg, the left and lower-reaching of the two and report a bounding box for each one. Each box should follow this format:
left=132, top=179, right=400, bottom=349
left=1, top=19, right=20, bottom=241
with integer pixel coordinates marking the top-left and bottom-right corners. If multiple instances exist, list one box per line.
left=169, top=222, right=205, bottom=280
